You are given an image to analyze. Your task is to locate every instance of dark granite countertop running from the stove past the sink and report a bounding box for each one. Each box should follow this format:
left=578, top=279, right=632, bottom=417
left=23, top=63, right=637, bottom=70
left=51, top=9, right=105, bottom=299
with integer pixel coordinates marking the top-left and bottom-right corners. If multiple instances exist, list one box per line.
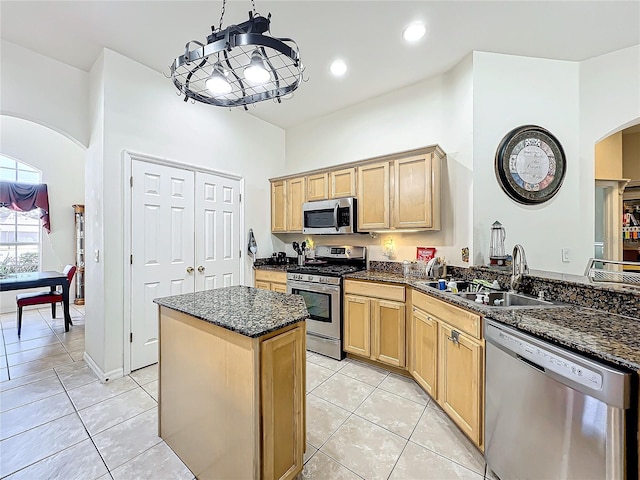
left=345, top=271, right=640, bottom=371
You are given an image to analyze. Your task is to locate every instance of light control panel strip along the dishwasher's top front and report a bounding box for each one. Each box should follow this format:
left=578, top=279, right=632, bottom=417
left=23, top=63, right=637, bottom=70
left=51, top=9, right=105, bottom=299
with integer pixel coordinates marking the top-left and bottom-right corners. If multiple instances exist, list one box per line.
left=496, top=329, right=602, bottom=390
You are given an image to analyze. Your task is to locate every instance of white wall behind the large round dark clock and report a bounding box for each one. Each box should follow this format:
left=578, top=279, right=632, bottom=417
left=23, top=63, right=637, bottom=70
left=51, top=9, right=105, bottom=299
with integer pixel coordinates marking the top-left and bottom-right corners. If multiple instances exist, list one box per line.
left=473, top=52, right=593, bottom=273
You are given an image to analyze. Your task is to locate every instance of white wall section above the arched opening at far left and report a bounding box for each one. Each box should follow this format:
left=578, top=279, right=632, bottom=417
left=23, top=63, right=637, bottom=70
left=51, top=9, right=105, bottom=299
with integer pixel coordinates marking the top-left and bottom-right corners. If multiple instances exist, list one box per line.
left=0, top=40, right=89, bottom=146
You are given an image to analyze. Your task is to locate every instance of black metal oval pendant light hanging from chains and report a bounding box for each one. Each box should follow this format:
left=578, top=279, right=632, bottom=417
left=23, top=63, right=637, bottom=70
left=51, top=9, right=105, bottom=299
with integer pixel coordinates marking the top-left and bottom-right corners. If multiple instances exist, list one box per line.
left=171, top=0, right=304, bottom=110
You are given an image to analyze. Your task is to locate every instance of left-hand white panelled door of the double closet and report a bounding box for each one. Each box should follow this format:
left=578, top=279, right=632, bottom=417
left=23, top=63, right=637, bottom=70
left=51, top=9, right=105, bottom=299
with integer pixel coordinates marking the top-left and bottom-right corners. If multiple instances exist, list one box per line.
left=131, top=160, right=196, bottom=370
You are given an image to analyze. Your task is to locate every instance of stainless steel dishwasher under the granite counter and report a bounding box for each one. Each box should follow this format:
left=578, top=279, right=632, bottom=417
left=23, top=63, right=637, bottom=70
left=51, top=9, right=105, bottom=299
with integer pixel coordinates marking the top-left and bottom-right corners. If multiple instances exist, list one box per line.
left=484, top=320, right=635, bottom=480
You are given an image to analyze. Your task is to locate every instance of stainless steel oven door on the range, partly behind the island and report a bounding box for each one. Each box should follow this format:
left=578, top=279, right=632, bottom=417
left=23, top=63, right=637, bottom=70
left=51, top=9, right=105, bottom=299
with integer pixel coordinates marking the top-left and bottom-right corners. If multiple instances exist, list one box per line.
left=287, top=280, right=341, bottom=339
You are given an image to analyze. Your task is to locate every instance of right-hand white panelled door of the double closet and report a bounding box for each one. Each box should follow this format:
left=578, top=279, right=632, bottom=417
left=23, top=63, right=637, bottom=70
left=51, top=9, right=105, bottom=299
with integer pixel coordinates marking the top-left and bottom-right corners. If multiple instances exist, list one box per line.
left=195, top=172, right=240, bottom=290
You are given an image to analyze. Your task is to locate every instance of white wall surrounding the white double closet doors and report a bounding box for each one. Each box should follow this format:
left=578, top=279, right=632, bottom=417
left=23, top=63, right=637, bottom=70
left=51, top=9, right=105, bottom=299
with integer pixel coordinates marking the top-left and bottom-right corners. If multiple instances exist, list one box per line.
left=87, top=50, right=284, bottom=378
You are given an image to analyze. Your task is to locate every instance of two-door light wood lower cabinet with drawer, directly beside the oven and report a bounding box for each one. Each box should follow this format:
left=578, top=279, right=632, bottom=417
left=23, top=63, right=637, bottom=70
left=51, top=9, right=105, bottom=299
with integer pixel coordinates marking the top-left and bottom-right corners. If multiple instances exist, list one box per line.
left=344, top=280, right=406, bottom=368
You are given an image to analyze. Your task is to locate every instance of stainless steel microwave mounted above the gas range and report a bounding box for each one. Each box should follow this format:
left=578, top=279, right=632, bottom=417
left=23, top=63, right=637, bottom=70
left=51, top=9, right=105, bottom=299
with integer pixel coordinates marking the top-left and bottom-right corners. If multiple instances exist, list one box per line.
left=302, top=197, right=357, bottom=235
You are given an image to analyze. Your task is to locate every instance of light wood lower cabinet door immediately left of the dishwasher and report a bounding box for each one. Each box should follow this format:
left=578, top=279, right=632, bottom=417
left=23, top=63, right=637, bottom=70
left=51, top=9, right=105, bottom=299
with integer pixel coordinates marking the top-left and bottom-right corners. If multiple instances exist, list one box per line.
left=438, top=322, right=484, bottom=446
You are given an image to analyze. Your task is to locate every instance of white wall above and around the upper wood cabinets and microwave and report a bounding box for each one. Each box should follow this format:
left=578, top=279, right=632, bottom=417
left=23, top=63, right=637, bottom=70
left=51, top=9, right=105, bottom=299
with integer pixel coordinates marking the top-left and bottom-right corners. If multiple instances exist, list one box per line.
left=284, top=56, right=472, bottom=265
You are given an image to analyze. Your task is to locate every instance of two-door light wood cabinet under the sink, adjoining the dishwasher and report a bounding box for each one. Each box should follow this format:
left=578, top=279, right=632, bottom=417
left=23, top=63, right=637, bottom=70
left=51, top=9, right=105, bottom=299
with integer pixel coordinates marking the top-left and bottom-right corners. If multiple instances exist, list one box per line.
left=409, top=290, right=484, bottom=449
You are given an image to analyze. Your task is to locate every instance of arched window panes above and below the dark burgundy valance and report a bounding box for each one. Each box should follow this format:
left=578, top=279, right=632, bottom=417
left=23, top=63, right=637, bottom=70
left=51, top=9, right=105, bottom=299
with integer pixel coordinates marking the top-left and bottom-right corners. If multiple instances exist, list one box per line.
left=0, top=155, right=42, bottom=274
